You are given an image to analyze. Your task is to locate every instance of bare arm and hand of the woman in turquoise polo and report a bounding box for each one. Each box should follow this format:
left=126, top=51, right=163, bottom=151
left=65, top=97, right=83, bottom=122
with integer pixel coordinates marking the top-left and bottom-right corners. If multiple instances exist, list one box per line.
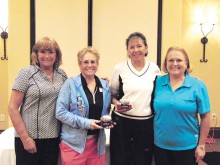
left=195, top=112, right=210, bottom=162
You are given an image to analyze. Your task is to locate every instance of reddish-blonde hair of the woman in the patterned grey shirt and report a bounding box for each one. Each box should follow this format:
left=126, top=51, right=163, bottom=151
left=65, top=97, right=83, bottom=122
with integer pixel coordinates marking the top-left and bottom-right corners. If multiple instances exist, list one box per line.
left=31, top=37, right=62, bottom=69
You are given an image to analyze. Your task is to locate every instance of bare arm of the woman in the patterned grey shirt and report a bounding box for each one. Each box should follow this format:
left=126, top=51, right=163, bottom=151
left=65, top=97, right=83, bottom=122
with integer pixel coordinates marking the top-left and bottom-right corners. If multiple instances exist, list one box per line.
left=8, top=90, right=37, bottom=153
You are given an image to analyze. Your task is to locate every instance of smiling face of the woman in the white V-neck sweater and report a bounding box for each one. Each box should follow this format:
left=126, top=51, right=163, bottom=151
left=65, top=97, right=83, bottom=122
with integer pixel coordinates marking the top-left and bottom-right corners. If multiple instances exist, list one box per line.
left=127, top=37, right=147, bottom=62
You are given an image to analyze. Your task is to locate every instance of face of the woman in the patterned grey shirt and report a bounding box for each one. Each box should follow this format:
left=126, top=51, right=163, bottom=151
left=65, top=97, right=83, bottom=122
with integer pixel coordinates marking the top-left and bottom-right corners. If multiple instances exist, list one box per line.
left=37, top=49, right=56, bottom=70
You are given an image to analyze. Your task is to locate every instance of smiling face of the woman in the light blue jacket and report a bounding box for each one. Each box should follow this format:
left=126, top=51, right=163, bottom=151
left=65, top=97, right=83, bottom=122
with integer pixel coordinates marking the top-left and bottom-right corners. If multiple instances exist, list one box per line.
left=79, top=52, right=98, bottom=78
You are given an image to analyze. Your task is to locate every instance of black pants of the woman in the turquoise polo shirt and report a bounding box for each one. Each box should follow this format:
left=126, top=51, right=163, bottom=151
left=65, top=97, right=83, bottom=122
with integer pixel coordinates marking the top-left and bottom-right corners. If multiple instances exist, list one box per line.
left=154, top=145, right=198, bottom=165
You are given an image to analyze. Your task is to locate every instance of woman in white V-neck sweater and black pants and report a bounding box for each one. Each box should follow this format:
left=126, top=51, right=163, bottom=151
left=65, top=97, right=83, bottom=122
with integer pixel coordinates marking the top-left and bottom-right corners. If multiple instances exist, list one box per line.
left=110, top=32, right=160, bottom=165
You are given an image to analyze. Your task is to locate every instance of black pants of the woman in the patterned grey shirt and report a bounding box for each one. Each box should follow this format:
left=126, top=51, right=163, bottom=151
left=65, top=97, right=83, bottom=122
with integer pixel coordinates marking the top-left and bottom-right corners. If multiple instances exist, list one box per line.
left=15, top=138, right=60, bottom=165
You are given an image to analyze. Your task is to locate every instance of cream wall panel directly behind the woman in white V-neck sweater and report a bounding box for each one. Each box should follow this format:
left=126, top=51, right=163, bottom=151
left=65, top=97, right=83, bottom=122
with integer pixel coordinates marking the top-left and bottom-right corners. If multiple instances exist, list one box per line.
left=93, top=0, right=158, bottom=77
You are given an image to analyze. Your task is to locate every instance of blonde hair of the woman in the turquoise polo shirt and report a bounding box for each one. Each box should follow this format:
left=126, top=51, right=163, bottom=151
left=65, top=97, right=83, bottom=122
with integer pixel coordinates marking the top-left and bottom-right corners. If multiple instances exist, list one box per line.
left=162, top=46, right=192, bottom=73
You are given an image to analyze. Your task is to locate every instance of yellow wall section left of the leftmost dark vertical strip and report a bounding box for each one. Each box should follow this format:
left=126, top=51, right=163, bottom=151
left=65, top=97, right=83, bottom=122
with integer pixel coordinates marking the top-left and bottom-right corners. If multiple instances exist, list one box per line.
left=0, top=0, right=30, bottom=130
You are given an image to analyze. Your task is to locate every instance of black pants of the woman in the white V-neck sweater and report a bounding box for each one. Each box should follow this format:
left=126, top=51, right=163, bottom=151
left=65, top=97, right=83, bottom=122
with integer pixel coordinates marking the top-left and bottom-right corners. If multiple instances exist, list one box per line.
left=110, top=112, right=154, bottom=165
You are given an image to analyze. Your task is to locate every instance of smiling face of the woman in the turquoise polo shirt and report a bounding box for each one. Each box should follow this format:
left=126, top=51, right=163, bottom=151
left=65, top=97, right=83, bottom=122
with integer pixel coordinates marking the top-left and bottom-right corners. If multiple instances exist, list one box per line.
left=166, top=50, right=187, bottom=76
